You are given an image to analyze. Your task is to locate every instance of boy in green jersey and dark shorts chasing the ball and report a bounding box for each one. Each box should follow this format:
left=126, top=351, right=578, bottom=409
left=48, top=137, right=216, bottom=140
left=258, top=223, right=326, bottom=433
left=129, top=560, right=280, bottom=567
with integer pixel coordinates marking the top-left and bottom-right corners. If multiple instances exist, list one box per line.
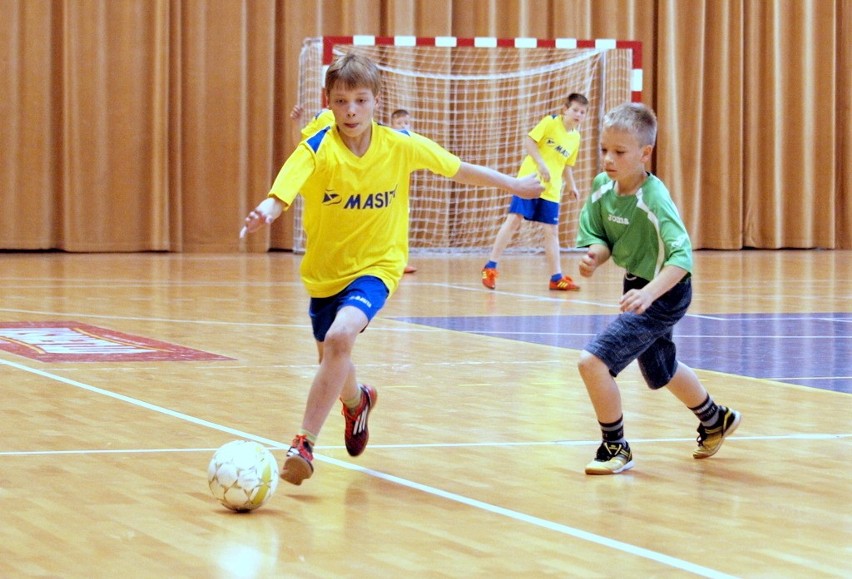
left=577, top=103, right=741, bottom=474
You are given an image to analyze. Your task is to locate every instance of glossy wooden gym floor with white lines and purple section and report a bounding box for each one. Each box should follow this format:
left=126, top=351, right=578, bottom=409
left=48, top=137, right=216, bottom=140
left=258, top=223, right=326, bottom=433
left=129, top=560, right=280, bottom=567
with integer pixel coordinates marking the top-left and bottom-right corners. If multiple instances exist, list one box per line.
left=0, top=251, right=852, bottom=578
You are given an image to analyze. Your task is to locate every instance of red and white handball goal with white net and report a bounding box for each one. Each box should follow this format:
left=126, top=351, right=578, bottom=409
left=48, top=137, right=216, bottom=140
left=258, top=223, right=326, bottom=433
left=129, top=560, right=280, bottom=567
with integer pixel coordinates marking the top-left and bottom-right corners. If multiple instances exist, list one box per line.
left=292, top=36, right=641, bottom=254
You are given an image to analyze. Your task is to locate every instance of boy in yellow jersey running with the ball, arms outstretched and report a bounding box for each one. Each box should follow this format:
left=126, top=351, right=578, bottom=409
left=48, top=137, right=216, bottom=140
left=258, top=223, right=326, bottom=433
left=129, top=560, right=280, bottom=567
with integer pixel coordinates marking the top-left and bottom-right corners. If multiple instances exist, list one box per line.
left=240, top=54, right=544, bottom=485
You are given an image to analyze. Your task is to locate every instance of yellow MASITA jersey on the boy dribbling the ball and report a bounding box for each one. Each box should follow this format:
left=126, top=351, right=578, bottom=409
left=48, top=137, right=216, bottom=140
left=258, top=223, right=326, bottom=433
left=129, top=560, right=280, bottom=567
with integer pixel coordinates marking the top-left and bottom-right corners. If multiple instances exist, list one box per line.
left=269, top=121, right=461, bottom=298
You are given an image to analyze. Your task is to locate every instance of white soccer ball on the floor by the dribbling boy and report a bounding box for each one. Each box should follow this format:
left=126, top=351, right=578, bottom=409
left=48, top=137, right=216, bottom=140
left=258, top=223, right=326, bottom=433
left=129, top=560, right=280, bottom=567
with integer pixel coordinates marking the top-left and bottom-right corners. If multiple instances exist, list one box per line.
left=207, top=440, right=278, bottom=512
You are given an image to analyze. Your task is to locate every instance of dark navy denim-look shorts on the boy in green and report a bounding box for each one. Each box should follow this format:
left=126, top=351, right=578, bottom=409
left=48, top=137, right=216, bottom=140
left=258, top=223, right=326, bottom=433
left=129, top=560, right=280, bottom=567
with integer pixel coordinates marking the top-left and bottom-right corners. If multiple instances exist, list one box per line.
left=585, top=274, right=692, bottom=390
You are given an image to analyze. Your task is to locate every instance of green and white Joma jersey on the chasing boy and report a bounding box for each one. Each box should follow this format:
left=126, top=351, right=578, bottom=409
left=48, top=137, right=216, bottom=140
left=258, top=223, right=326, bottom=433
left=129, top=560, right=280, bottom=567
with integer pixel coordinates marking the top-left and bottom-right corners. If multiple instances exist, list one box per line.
left=577, top=173, right=692, bottom=280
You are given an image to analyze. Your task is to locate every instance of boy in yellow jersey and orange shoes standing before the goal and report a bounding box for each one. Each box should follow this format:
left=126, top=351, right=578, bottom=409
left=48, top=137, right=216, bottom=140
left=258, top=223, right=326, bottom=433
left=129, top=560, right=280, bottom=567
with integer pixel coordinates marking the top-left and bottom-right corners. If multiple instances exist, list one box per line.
left=482, top=93, right=589, bottom=291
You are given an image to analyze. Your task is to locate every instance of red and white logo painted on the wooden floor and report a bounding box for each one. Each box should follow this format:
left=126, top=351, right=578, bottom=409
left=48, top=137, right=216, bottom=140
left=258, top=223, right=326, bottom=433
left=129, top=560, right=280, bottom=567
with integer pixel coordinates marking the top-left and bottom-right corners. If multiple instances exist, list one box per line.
left=0, top=322, right=233, bottom=362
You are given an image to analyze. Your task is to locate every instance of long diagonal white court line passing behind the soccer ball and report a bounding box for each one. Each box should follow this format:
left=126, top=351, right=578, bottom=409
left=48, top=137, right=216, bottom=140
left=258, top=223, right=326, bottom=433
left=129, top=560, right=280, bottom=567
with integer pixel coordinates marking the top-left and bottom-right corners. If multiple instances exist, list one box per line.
left=0, top=359, right=732, bottom=579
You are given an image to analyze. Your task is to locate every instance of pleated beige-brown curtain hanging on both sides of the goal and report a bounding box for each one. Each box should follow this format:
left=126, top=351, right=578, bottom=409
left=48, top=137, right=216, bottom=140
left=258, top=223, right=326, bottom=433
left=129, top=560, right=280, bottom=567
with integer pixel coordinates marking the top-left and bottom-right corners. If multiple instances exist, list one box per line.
left=0, top=0, right=852, bottom=252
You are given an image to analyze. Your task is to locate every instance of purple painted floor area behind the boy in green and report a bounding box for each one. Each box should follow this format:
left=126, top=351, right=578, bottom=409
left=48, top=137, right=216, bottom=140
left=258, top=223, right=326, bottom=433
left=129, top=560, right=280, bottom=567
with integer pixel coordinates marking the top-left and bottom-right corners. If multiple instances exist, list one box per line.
left=394, top=313, right=852, bottom=394
